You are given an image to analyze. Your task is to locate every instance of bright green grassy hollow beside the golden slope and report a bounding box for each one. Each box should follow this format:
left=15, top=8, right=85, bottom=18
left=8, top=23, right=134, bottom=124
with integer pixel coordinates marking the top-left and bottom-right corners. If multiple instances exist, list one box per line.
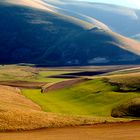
left=22, top=79, right=140, bottom=116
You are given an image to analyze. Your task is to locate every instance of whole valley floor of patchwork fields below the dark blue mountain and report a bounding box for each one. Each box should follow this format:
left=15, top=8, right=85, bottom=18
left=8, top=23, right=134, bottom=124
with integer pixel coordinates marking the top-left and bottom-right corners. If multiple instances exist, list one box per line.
left=0, top=65, right=140, bottom=137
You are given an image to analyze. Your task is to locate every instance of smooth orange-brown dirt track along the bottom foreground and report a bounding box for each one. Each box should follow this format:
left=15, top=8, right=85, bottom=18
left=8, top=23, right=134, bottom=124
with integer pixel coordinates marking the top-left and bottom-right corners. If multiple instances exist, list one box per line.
left=0, top=121, right=140, bottom=140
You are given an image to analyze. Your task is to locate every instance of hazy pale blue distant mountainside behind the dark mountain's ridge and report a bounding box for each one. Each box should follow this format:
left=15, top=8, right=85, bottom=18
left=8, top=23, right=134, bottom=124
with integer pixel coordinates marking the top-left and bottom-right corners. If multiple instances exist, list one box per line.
left=44, top=0, right=140, bottom=37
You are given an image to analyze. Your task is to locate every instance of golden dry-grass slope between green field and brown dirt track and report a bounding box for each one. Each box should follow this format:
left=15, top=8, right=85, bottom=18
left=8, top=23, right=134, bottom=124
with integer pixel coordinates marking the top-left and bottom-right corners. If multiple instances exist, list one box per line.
left=0, top=86, right=129, bottom=131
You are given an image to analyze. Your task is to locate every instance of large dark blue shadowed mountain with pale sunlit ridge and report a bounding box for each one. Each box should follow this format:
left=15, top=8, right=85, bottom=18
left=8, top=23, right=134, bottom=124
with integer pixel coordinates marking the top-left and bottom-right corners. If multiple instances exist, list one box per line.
left=0, top=0, right=140, bottom=66
